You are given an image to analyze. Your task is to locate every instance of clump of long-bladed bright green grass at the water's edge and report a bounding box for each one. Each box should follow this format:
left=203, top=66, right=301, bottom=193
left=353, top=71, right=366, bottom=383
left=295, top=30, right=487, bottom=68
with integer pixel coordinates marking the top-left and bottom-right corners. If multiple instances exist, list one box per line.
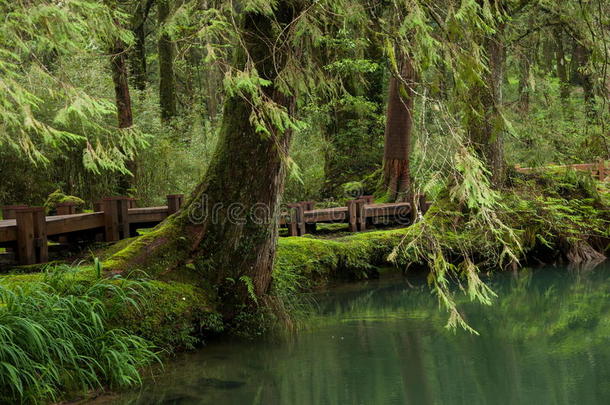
left=0, top=271, right=158, bottom=403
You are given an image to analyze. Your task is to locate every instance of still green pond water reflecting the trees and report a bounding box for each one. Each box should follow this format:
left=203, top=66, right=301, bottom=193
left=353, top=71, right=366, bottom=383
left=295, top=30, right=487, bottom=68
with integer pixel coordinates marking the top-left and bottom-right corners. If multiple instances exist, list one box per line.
left=104, top=265, right=610, bottom=405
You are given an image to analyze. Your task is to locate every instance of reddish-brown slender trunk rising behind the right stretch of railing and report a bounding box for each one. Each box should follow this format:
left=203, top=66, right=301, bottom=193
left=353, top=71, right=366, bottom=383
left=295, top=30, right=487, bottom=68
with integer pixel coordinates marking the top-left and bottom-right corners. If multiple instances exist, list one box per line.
left=383, top=55, right=415, bottom=201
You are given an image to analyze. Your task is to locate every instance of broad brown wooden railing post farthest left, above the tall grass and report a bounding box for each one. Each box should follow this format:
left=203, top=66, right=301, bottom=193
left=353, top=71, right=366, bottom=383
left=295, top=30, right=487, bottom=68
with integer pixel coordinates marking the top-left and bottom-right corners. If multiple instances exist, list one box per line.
left=15, top=207, right=49, bottom=265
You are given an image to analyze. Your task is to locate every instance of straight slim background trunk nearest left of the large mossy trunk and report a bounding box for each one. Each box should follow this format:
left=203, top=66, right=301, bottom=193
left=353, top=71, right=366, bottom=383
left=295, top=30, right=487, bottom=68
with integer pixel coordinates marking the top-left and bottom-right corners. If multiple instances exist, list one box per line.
left=157, top=0, right=176, bottom=122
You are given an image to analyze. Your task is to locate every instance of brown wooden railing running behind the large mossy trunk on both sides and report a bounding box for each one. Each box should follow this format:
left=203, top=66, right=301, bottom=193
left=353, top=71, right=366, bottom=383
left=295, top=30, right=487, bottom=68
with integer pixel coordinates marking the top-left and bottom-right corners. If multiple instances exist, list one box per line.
left=0, top=194, right=429, bottom=265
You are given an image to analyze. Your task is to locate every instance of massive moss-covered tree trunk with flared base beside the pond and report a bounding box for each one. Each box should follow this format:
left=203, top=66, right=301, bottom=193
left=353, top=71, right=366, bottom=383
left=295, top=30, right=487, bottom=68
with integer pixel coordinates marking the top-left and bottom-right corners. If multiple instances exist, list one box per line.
left=107, top=1, right=297, bottom=321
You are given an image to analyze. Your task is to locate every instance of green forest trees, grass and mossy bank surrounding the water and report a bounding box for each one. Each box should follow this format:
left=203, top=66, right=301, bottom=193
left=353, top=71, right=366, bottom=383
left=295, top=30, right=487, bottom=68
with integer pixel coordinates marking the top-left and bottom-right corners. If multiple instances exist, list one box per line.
left=0, top=0, right=610, bottom=402
